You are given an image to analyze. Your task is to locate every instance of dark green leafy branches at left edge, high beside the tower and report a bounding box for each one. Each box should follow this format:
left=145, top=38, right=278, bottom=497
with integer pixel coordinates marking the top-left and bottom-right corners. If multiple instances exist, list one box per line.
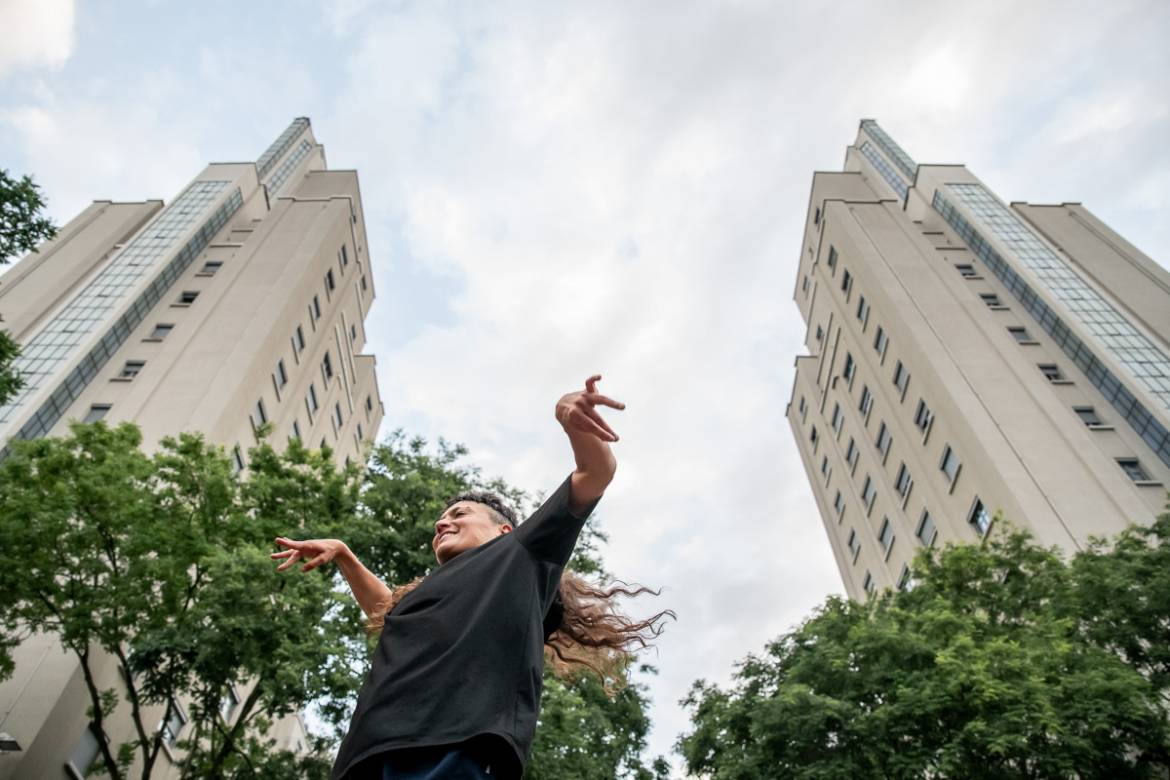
left=0, top=168, right=57, bottom=405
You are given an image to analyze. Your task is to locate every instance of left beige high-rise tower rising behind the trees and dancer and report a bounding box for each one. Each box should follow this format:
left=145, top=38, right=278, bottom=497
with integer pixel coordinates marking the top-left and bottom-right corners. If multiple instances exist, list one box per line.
left=0, top=118, right=383, bottom=779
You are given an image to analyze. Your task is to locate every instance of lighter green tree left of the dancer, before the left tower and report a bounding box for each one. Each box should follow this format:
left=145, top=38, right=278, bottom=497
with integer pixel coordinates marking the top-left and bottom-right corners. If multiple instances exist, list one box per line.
left=0, top=422, right=358, bottom=778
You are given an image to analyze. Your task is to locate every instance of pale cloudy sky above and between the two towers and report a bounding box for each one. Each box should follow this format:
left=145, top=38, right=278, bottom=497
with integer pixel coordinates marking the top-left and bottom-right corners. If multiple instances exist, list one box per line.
left=0, top=0, right=1170, bottom=767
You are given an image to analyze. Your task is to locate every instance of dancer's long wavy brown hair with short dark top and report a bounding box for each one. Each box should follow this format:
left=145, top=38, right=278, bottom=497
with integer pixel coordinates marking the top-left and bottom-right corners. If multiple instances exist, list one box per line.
left=367, top=490, right=676, bottom=696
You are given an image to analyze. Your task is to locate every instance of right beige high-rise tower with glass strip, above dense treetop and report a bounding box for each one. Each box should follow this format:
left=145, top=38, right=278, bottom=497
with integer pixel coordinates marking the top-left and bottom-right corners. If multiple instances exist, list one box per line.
left=787, top=119, right=1170, bottom=599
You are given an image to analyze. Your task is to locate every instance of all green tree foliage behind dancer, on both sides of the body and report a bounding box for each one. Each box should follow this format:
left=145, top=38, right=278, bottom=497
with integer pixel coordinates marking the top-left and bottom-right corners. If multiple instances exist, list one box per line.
left=0, top=422, right=653, bottom=780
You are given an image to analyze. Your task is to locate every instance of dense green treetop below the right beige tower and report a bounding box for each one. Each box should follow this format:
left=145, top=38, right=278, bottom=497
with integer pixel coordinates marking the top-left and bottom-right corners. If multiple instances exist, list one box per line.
left=677, top=516, right=1170, bottom=780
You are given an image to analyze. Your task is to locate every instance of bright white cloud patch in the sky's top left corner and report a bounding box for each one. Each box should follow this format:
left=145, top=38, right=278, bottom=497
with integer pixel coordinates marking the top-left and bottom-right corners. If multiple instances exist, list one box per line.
left=0, top=0, right=74, bottom=78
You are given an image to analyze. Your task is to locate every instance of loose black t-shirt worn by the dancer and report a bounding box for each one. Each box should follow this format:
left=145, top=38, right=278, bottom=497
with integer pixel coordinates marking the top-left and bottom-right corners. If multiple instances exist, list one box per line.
left=332, top=477, right=597, bottom=780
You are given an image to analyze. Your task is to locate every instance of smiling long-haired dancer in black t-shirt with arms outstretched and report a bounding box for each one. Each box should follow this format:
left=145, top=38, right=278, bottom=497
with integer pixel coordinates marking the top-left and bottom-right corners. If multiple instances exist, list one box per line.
left=273, top=374, right=673, bottom=780
